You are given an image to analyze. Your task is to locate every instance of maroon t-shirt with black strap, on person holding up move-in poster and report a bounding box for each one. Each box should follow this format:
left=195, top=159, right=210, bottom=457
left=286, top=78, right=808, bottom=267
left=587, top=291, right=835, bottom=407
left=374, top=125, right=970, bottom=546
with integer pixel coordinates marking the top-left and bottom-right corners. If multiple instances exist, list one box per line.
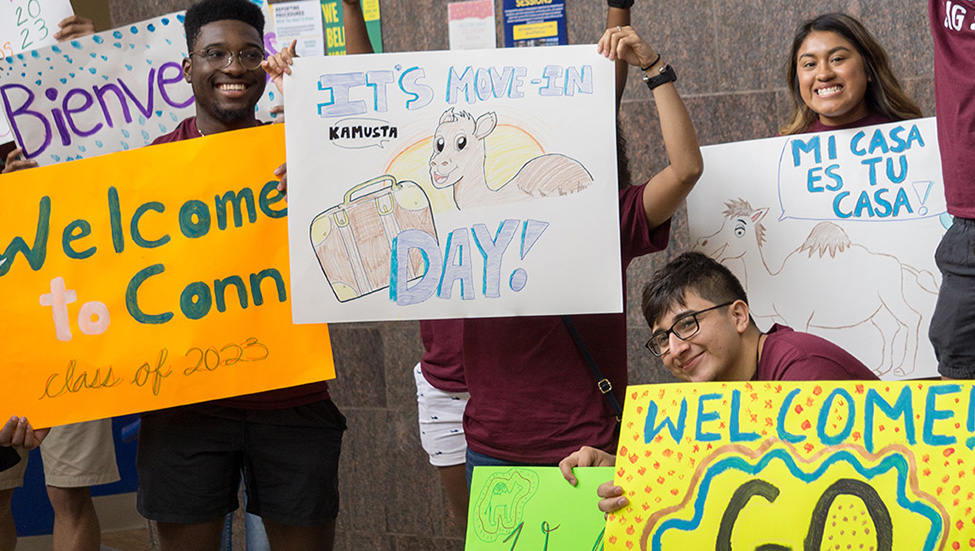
left=464, top=185, right=670, bottom=464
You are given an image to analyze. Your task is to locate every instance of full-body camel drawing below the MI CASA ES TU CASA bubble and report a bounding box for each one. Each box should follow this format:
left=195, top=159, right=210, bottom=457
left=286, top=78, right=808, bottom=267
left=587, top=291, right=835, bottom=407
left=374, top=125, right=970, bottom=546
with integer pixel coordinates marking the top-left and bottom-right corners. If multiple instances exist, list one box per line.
left=694, top=198, right=938, bottom=376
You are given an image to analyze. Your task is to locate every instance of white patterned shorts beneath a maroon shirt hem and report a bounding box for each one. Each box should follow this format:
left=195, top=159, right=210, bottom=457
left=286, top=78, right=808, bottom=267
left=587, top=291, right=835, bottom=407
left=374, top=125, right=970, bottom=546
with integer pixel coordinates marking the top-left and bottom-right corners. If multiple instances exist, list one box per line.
left=413, top=363, right=471, bottom=467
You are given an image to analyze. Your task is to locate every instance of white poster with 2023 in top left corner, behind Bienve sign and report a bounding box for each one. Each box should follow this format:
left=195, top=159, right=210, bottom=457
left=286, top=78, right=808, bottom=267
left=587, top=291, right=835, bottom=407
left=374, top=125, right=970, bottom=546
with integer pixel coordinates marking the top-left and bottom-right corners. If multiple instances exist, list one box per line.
left=0, top=0, right=74, bottom=143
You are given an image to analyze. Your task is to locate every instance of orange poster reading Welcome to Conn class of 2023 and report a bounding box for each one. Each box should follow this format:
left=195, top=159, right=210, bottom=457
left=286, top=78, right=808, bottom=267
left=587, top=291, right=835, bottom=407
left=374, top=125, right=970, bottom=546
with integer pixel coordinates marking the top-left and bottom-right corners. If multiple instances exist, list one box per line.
left=0, top=125, right=335, bottom=427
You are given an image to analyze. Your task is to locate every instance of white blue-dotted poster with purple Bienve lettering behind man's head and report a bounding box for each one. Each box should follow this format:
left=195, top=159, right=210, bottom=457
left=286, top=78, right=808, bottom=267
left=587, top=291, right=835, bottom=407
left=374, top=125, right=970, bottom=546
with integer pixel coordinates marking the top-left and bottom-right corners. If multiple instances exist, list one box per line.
left=0, top=12, right=280, bottom=166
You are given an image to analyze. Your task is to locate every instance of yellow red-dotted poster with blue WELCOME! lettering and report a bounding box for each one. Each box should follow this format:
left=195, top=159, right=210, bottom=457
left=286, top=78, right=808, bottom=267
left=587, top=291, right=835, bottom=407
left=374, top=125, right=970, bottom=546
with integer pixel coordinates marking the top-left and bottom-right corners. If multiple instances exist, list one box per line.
left=605, top=381, right=975, bottom=551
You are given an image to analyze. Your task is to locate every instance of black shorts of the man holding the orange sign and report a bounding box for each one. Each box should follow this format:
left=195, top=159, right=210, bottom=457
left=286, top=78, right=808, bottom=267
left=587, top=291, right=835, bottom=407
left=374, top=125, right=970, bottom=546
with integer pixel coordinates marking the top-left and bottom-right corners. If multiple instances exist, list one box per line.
left=136, top=400, right=345, bottom=526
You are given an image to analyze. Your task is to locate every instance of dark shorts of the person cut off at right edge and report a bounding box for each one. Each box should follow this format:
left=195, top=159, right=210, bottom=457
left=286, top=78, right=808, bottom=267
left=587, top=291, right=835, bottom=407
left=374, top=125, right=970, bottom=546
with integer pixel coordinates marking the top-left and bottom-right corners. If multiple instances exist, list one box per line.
left=928, top=218, right=975, bottom=379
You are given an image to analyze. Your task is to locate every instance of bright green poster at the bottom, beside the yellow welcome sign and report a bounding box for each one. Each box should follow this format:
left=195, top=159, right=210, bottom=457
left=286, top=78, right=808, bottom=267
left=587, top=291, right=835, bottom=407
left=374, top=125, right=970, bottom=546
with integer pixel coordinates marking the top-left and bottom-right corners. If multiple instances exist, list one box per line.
left=465, top=467, right=613, bottom=551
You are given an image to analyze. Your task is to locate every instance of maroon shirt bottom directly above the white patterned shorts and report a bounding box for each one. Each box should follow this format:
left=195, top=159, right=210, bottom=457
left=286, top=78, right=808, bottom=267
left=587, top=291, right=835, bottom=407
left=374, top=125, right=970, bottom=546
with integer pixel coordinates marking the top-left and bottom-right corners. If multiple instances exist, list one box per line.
left=420, top=320, right=467, bottom=392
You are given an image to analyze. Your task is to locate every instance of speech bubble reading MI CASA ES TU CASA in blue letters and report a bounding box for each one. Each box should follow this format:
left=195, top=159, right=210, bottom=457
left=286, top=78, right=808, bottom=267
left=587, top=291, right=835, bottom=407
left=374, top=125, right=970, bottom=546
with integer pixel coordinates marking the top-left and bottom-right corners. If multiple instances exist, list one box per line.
left=778, top=120, right=946, bottom=221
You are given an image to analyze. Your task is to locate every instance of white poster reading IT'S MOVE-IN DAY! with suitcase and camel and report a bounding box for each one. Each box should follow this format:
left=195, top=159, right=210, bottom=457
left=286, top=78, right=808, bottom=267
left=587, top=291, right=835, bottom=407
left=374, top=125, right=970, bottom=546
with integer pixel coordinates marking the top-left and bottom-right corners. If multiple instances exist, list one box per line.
left=285, top=46, right=622, bottom=323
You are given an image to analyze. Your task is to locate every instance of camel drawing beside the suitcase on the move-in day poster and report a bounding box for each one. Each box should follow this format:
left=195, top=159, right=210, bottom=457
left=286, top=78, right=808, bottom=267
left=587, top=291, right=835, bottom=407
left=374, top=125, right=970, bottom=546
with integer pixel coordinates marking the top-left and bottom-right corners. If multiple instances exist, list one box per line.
left=430, top=107, right=593, bottom=209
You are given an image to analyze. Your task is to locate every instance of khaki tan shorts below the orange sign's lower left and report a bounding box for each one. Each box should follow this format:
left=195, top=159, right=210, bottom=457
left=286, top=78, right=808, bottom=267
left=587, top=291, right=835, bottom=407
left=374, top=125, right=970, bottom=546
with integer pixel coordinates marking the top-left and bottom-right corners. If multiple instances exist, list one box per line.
left=0, top=419, right=119, bottom=490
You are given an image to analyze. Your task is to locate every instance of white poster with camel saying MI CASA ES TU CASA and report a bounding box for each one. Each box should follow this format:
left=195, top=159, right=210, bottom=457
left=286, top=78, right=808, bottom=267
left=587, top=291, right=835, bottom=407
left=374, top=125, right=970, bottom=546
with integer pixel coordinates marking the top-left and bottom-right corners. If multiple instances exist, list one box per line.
left=687, top=118, right=951, bottom=379
